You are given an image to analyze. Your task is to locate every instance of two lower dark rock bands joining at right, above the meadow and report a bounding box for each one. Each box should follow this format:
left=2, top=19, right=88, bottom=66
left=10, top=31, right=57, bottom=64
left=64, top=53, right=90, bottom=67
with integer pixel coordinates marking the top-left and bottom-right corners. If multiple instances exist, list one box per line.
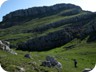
left=18, top=12, right=96, bottom=51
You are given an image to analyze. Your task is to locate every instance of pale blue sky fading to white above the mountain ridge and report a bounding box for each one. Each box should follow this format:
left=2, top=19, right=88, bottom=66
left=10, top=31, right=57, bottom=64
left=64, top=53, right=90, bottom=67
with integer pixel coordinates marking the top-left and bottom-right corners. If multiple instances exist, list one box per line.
left=0, top=0, right=96, bottom=21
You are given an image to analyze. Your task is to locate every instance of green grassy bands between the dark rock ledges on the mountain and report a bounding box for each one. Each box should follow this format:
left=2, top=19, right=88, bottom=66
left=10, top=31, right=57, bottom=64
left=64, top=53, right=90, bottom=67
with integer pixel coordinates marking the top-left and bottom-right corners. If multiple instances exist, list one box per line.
left=0, top=10, right=89, bottom=44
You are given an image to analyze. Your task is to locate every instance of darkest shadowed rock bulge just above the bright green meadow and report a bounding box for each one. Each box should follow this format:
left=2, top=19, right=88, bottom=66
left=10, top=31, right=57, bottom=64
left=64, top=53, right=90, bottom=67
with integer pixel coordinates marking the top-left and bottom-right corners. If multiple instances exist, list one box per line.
left=18, top=30, right=73, bottom=51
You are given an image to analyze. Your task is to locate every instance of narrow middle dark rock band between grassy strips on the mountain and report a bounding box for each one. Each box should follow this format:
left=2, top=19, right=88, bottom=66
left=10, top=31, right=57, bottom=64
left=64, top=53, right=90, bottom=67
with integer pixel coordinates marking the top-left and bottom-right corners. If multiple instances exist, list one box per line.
left=29, top=12, right=94, bottom=32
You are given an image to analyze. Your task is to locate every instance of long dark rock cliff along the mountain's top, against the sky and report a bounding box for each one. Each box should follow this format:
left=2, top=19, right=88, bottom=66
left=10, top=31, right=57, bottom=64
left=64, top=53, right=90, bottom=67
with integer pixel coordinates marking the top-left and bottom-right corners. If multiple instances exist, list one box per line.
left=0, top=4, right=82, bottom=28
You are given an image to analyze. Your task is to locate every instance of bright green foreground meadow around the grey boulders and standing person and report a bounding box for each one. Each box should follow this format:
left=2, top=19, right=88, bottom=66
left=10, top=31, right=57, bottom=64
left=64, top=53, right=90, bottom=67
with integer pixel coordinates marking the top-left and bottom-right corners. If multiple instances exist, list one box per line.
left=0, top=39, right=96, bottom=72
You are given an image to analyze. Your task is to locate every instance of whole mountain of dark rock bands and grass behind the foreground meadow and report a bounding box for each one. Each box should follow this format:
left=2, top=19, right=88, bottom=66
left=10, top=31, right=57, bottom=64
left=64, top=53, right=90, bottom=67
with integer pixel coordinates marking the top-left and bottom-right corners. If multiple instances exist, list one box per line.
left=0, top=4, right=96, bottom=51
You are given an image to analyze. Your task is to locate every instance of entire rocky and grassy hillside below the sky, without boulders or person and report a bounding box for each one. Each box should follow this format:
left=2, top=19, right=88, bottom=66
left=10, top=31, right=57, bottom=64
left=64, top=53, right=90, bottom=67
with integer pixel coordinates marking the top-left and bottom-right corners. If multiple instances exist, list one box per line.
left=0, top=4, right=96, bottom=72
